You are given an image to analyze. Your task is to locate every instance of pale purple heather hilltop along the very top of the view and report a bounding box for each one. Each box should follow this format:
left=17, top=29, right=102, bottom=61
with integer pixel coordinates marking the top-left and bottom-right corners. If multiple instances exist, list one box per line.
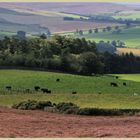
left=0, top=2, right=133, bottom=15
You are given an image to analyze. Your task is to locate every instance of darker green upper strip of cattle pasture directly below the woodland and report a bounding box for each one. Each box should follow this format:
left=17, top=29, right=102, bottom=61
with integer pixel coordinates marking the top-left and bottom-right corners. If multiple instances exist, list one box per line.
left=0, top=70, right=140, bottom=94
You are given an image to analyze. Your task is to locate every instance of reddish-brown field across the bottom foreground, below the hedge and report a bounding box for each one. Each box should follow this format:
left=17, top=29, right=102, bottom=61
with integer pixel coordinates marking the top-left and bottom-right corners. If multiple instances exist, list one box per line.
left=0, top=107, right=140, bottom=137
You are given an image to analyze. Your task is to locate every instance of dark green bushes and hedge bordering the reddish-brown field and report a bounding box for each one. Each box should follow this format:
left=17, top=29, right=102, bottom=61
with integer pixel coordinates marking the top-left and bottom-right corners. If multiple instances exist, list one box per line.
left=12, top=100, right=140, bottom=116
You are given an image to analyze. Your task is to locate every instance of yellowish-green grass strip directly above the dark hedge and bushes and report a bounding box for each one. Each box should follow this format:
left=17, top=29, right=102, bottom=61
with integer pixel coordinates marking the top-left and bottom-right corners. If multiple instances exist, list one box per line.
left=0, top=93, right=140, bottom=109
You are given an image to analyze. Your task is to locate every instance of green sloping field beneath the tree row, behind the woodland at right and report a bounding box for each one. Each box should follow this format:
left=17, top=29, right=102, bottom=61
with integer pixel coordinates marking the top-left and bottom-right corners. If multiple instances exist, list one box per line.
left=67, top=26, right=140, bottom=48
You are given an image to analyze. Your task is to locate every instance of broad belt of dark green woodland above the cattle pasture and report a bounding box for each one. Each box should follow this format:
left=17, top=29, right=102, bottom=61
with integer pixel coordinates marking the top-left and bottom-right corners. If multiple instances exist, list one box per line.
left=0, top=36, right=140, bottom=75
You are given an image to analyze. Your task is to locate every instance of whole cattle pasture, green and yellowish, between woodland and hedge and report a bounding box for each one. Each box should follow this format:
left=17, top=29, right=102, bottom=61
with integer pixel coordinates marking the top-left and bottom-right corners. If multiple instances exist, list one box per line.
left=0, top=70, right=140, bottom=108
